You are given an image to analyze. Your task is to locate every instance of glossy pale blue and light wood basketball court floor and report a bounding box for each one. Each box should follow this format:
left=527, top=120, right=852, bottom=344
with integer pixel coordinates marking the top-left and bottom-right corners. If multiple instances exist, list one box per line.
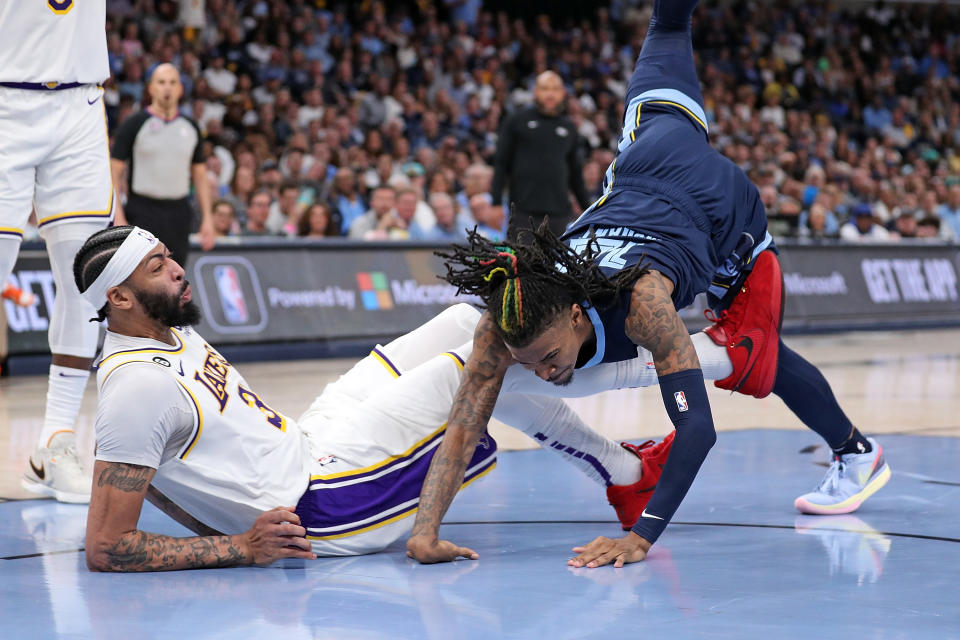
left=0, top=332, right=960, bottom=639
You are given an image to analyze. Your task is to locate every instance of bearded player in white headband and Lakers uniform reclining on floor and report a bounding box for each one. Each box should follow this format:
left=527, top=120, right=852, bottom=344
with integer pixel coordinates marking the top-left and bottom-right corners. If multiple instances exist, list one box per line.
left=74, top=226, right=692, bottom=571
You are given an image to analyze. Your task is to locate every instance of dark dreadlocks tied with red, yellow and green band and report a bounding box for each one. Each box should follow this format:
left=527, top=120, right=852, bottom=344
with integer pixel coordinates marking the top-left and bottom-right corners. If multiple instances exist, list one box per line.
left=435, top=223, right=647, bottom=347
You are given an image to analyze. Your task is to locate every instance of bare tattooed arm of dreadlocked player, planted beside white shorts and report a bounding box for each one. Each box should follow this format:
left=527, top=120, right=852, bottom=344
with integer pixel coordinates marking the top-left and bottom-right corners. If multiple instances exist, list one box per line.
left=407, top=313, right=513, bottom=562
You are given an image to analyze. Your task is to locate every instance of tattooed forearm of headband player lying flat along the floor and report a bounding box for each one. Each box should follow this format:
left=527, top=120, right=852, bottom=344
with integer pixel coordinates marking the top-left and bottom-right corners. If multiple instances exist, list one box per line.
left=104, top=531, right=248, bottom=571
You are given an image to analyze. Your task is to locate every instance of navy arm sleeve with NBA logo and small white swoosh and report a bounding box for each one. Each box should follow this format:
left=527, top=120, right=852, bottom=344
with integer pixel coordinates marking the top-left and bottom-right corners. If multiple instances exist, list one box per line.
left=631, top=369, right=717, bottom=543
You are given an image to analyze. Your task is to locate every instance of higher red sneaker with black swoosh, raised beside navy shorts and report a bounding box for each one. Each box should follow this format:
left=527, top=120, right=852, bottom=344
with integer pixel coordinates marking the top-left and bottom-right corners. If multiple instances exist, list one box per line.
left=703, top=251, right=783, bottom=398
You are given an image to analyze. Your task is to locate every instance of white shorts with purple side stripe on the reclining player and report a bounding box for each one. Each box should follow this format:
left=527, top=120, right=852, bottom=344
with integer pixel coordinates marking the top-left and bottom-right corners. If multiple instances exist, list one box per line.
left=297, top=305, right=497, bottom=555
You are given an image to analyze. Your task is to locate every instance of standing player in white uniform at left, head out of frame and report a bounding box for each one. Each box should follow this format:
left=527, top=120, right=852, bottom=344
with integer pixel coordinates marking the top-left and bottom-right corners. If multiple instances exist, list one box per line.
left=0, top=0, right=113, bottom=502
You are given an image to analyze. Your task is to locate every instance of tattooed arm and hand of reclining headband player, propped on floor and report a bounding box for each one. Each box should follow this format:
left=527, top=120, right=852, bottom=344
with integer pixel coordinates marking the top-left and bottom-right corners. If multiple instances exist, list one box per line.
left=86, top=460, right=315, bottom=571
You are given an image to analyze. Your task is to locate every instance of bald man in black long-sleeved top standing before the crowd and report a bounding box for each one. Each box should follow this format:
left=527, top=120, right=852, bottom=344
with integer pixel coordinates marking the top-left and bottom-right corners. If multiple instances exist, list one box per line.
left=491, top=71, right=590, bottom=241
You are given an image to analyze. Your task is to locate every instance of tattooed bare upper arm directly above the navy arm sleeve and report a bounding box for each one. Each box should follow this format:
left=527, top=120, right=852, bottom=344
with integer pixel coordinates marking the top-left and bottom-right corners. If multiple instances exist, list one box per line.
left=626, top=271, right=700, bottom=376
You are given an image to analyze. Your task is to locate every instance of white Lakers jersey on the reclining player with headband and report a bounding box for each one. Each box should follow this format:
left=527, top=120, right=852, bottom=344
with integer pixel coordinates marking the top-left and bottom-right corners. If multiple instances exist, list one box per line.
left=96, top=329, right=310, bottom=534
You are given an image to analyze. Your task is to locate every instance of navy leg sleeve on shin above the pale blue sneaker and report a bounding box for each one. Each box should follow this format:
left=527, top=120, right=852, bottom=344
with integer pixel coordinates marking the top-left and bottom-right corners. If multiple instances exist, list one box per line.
left=772, top=340, right=853, bottom=448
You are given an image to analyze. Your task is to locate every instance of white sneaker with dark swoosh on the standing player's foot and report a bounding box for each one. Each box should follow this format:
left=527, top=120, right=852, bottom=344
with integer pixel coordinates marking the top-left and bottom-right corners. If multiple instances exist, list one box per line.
left=20, top=431, right=93, bottom=503
